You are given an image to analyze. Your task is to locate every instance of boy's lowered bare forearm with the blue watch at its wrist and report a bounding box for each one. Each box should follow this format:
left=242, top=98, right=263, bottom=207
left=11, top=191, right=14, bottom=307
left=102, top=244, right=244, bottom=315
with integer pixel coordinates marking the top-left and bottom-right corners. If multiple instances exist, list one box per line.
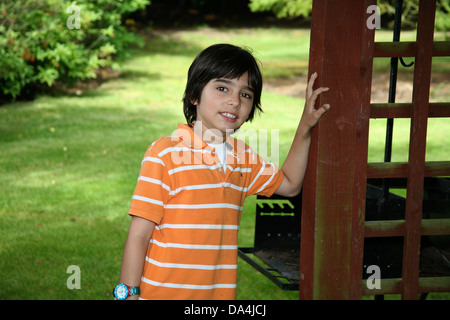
left=120, top=216, right=155, bottom=300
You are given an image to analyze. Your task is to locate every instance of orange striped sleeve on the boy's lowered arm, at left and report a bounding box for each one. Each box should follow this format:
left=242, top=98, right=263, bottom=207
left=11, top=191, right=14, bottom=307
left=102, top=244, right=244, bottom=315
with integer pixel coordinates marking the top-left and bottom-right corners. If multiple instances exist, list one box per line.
left=129, top=144, right=170, bottom=224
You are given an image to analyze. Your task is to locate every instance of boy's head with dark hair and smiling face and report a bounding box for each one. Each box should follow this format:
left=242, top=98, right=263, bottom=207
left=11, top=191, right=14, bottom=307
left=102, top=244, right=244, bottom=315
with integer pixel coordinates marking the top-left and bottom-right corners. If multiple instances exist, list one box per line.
left=183, top=44, right=262, bottom=131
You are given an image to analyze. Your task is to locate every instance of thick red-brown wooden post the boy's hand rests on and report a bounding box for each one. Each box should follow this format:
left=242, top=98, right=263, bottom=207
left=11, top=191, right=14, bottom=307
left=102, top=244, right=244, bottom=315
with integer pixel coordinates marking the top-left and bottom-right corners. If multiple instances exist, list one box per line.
left=299, top=0, right=376, bottom=299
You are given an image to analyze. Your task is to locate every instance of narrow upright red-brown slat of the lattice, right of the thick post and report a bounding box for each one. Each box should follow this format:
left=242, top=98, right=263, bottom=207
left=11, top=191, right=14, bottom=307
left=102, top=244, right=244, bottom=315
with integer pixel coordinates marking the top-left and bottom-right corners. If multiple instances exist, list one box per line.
left=402, top=0, right=436, bottom=299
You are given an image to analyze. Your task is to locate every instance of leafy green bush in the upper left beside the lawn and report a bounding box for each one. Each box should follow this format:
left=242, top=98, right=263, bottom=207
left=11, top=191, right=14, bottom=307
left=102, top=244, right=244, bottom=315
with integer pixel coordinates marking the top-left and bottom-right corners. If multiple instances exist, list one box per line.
left=0, top=0, right=150, bottom=98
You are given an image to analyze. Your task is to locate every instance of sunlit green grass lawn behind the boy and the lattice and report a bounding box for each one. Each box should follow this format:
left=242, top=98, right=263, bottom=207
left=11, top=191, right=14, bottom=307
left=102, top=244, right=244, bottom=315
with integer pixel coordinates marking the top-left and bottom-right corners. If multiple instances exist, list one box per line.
left=0, top=28, right=450, bottom=299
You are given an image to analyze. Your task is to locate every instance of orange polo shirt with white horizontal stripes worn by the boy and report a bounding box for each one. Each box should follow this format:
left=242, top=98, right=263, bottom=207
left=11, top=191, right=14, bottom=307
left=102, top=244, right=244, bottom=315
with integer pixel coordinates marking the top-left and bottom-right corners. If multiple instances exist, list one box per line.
left=129, top=124, right=283, bottom=300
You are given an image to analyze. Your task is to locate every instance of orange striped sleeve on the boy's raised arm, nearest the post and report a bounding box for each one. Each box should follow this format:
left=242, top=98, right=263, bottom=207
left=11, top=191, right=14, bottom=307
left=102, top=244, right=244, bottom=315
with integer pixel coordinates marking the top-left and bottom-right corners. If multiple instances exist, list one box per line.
left=246, top=149, right=283, bottom=197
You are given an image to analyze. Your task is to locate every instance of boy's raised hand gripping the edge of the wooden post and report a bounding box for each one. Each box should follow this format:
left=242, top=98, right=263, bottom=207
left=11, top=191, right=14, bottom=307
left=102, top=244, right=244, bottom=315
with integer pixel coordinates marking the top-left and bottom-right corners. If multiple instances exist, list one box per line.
left=300, top=72, right=330, bottom=131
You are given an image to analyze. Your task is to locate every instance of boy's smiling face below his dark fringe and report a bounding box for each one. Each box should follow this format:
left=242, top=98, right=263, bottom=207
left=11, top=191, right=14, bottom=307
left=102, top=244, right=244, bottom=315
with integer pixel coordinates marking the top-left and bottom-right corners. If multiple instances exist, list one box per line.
left=193, top=72, right=253, bottom=143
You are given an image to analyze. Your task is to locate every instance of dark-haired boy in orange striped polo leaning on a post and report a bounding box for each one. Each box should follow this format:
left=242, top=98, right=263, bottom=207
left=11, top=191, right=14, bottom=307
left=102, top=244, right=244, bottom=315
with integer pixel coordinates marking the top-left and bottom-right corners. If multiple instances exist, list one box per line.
left=115, top=44, right=329, bottom=300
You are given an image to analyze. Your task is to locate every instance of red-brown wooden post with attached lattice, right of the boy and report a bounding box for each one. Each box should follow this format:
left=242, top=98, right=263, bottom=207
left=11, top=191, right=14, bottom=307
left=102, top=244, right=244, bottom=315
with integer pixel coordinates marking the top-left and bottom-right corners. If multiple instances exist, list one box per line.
left=299, top=0, right=450, bottom=299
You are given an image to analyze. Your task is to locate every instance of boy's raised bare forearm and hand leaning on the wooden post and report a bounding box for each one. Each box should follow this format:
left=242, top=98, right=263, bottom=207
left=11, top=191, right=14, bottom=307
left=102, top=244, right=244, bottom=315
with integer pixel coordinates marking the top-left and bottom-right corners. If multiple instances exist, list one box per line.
left=275, top=72, right=330, bottom=197
